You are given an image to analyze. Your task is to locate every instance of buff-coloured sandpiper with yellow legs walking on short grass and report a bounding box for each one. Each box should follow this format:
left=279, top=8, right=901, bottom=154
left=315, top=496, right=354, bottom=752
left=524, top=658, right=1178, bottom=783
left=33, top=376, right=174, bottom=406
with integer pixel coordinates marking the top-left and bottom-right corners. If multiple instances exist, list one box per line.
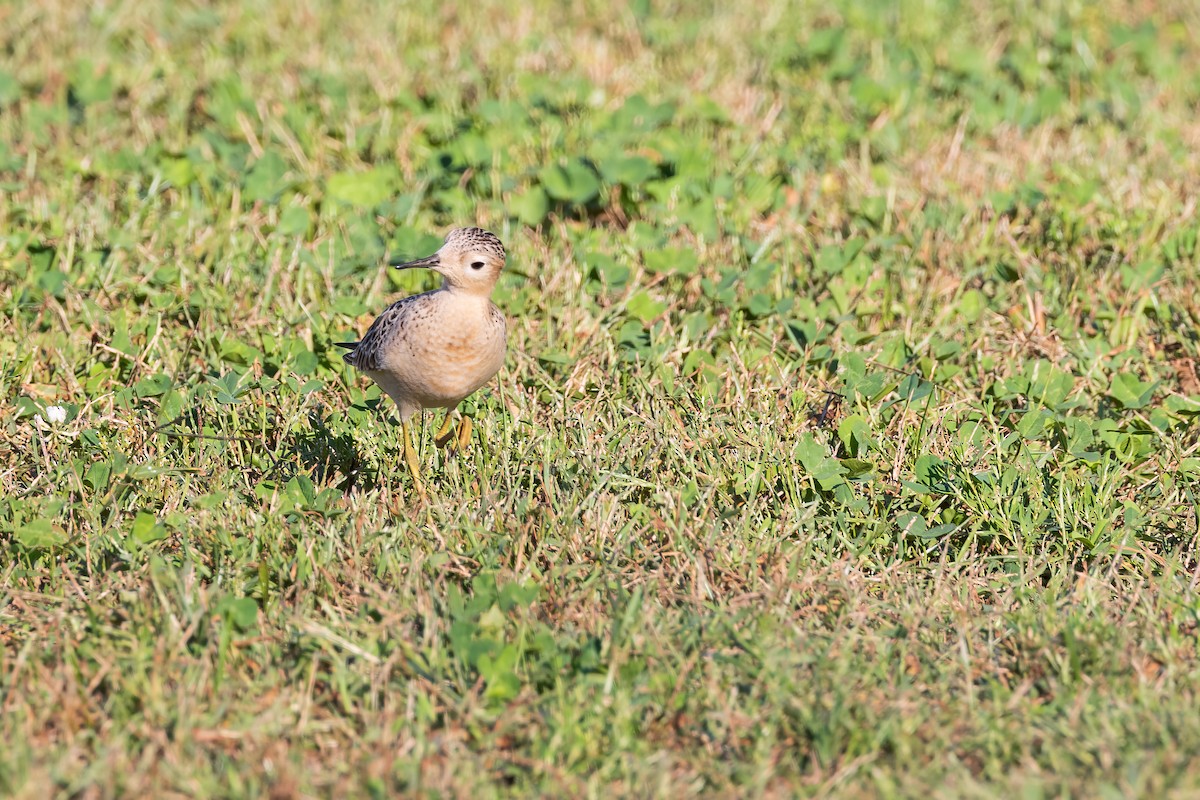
left=335, top=228, right=508, bottom=495
